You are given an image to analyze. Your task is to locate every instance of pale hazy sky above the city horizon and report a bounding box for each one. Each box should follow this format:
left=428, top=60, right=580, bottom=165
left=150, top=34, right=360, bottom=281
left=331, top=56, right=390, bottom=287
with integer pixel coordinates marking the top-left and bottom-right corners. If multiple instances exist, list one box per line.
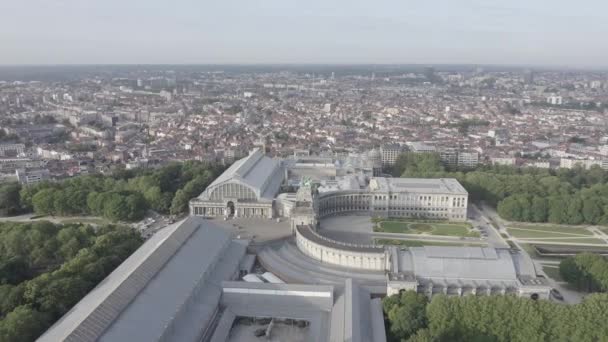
left=0, top=0, right=608, bottom=66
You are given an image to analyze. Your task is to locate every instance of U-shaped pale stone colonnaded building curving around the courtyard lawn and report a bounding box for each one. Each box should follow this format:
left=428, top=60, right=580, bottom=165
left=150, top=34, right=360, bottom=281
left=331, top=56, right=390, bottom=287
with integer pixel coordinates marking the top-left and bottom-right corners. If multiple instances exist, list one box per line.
left=292, top=183, right=551, bottom=299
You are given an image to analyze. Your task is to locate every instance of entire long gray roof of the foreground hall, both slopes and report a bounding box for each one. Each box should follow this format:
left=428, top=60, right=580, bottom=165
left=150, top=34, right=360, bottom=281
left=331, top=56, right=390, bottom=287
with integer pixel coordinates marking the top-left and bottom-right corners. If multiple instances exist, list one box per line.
left=39, top=217, right=246, bottom=342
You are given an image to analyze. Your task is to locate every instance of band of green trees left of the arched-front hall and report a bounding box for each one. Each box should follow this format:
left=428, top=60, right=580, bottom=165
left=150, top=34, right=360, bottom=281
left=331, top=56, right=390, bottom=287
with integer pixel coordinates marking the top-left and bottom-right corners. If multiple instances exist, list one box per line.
left=0, top=161, right=222, bottom=221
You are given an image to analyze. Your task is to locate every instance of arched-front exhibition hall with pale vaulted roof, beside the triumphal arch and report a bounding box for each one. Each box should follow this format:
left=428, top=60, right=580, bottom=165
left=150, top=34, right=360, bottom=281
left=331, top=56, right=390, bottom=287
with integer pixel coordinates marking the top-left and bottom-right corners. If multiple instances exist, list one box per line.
left=190, top=149, right=283, bottom=218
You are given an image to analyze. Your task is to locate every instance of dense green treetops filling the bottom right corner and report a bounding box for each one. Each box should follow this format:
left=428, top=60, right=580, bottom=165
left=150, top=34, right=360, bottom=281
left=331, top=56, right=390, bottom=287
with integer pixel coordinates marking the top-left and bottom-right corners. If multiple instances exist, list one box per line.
left=382, top=291, right=608, bottom=342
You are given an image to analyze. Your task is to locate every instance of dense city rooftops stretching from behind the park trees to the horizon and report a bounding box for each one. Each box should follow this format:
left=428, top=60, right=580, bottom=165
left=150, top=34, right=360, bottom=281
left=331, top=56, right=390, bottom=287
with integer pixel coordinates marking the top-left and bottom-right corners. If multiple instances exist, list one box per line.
left=0, top=66, right=608, bottom=182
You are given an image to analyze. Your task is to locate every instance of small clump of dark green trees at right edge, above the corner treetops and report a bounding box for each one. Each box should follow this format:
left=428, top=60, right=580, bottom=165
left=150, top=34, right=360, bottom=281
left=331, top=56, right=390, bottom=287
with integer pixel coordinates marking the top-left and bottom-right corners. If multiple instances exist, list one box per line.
left=559, top=253, right=608, bottom=292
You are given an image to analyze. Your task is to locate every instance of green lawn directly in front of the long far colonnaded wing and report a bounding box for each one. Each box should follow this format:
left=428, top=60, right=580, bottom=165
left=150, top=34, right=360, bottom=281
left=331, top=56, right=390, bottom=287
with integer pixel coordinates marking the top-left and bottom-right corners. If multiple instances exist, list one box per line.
left=374, top=220, right=479, bottom=237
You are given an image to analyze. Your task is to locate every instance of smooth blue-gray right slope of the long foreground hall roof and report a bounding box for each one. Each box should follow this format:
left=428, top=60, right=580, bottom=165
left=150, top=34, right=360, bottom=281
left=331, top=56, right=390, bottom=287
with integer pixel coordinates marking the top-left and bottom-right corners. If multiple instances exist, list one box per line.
left=100, top=221, right=245, bottom=342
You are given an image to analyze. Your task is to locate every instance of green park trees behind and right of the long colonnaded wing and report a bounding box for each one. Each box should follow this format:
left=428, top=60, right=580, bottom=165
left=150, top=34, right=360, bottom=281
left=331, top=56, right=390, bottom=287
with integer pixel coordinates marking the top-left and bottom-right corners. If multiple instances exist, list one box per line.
left=392, top=153, right=608, bottom=224
